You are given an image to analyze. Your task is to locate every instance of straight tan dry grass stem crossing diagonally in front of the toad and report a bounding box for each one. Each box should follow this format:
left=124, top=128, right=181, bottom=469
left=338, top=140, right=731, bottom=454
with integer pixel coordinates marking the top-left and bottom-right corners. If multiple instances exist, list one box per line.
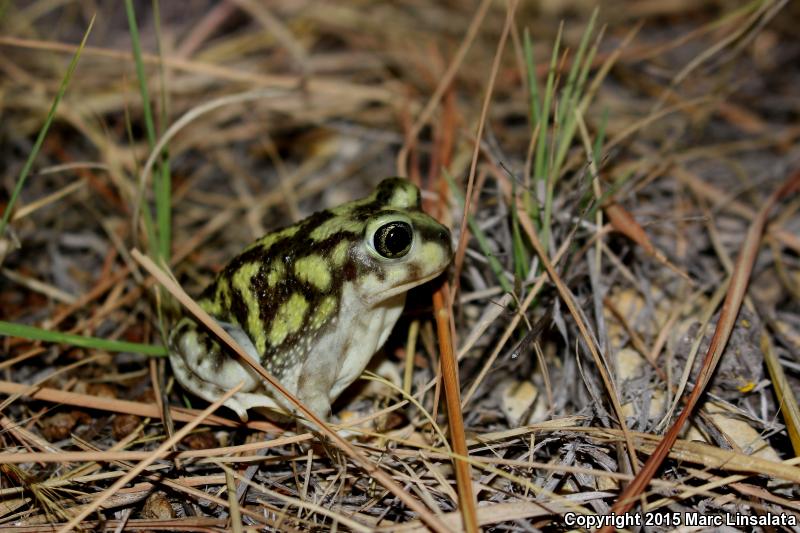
left=131, top=250, right=454, bottom=532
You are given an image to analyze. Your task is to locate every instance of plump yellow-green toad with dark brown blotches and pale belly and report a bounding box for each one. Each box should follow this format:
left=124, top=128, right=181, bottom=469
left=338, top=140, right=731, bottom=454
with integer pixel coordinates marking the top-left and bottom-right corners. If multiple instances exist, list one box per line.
left=170, top=178, right=452, bottom=420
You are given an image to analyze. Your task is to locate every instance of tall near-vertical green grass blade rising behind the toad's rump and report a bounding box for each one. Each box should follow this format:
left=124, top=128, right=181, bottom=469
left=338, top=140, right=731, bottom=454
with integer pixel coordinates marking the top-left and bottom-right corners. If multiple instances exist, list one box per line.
left=125, top=0, right=172, bottom=263
